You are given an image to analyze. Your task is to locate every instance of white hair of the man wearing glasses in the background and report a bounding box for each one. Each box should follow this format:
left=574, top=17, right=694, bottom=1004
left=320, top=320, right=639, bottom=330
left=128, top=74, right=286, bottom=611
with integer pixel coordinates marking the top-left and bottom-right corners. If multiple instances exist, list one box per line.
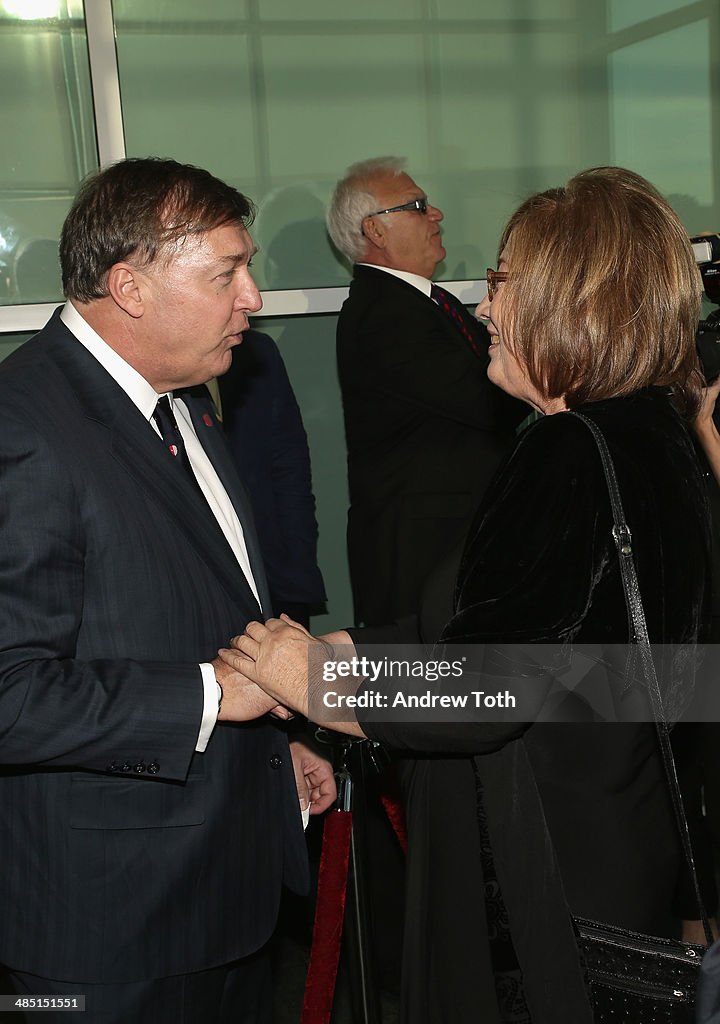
left=328, top=157, right=407, bottom=263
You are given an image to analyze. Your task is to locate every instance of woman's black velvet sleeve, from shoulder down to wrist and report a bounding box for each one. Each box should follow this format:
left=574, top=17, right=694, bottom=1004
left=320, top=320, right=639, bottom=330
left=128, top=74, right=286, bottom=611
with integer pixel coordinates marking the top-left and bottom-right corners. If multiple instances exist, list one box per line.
left=358, top=415, right=614, bottom=755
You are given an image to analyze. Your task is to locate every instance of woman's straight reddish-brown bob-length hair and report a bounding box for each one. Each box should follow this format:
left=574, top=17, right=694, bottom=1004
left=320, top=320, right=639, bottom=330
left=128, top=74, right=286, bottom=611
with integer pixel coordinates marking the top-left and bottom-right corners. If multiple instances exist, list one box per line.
left=500, top=167, right=703, bottom=416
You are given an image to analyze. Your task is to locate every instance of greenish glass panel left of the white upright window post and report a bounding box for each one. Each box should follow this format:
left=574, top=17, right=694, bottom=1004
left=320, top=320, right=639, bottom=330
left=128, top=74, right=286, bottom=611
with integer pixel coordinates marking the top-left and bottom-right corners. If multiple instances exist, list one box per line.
left=0, top=0, right=97, bottom=305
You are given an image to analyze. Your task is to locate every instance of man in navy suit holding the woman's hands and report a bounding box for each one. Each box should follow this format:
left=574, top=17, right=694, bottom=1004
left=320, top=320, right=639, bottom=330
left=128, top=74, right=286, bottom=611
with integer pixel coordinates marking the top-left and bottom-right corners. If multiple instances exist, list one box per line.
left=0, top=160, right=334, bottom=1024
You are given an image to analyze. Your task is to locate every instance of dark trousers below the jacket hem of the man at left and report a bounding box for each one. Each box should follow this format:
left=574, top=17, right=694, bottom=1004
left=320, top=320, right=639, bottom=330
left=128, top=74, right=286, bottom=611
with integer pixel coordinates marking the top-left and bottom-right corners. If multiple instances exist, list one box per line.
left=7, top=949, right=272, bottom=1024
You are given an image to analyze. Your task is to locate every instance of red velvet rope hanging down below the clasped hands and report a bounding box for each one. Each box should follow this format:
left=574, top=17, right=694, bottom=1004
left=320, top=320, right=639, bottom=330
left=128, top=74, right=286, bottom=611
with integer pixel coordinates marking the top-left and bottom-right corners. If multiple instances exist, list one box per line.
left=300, top=811, right=352, bottom=1024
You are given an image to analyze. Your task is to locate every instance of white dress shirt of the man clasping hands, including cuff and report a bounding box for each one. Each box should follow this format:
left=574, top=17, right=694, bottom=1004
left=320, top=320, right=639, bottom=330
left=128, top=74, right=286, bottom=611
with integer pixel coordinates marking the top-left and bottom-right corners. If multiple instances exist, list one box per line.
left=60, top=301, right=260, bottom=754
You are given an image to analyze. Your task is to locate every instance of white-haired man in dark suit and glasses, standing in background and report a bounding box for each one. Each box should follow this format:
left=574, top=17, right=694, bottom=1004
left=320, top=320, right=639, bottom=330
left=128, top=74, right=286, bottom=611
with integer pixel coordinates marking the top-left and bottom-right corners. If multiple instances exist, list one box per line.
left=328, top=158, right=528, bottom=626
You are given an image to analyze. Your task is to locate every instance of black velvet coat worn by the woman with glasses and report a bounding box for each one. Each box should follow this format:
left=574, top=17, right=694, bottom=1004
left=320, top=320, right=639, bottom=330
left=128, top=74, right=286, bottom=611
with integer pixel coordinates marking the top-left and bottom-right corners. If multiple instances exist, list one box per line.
left=363, top=391, right=709, bottom=1024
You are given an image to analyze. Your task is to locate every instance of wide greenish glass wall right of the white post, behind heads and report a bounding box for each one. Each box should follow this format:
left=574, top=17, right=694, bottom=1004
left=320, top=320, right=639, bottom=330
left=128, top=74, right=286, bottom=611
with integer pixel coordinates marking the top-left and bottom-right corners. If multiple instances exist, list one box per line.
left=115, top=0, right=717, bottom=289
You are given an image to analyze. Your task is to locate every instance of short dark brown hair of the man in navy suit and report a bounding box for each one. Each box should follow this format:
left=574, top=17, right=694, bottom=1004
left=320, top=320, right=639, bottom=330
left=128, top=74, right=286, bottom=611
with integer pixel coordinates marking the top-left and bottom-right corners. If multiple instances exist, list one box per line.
left=60, top=158, right=254, bottom=302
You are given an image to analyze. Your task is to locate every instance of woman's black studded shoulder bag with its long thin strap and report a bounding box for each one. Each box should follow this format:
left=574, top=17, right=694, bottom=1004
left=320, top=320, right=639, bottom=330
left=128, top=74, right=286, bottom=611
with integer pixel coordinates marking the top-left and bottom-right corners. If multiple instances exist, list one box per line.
left=566, top=413, right=713, bottom=1024
